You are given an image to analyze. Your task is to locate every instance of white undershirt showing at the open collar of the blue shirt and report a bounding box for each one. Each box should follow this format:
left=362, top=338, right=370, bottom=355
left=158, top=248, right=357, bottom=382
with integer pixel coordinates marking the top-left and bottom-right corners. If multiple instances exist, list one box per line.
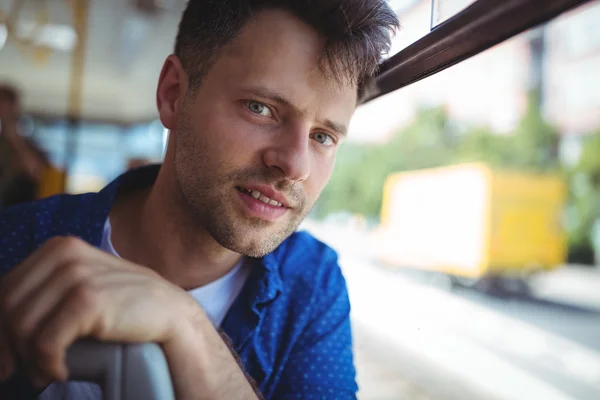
left=100, top=218, right=250, bottom=327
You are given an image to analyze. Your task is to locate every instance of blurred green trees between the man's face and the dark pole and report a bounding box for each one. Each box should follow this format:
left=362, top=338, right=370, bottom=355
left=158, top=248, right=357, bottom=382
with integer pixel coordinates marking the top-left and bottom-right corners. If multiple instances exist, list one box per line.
left=316, top=95, right=558, bottom=217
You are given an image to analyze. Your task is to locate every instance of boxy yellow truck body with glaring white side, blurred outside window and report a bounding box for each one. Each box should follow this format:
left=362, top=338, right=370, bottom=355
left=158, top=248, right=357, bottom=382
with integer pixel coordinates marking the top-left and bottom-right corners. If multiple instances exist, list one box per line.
left=380, top=164, right=567, bottom=279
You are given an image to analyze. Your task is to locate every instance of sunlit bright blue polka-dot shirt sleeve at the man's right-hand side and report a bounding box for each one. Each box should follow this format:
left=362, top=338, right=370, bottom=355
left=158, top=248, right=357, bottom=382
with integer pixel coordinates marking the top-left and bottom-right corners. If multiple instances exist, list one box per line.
left=273, top=260, right=358, bottom=400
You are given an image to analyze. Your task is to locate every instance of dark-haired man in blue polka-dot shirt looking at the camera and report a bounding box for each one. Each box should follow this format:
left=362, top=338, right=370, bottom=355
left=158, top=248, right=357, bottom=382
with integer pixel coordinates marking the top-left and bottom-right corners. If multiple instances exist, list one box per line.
left=0, top=0, right=397, bottom=400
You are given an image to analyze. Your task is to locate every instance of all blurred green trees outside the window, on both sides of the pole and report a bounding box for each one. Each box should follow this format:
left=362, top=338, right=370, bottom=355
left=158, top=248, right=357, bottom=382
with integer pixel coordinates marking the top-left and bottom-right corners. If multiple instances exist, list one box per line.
left=315, top=93, right=600, bottom=258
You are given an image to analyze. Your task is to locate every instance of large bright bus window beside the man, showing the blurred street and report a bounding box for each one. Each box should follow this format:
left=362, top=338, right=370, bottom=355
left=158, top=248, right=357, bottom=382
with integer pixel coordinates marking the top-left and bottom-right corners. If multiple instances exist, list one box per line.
left=307, top=1, right=600, bottom=400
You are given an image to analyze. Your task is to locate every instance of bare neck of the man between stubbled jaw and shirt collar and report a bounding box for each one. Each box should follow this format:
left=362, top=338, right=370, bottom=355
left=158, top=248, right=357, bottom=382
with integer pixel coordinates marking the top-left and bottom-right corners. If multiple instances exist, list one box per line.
left=110, top=165, right=241, bottom=290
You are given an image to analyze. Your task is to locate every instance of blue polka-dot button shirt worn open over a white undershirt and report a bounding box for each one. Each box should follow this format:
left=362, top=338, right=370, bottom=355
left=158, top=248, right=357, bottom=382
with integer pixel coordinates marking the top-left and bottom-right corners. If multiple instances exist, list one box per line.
left=0, top=166, right=358, bottom=400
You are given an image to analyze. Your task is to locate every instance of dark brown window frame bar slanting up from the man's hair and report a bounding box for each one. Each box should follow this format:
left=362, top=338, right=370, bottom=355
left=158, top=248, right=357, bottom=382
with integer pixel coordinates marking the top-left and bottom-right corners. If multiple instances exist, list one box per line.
left=363, top=0, right=591, bottom=103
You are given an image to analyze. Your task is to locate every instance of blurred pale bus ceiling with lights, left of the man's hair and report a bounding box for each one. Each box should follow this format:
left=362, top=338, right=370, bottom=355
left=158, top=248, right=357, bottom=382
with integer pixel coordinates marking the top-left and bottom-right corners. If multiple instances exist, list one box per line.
left=0, top=0, right=185, bottom=124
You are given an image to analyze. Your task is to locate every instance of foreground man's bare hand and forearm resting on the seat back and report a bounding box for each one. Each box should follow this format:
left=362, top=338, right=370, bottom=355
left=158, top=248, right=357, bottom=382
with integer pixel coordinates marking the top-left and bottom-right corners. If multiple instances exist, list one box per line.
left=0, top=238, right=257, bottom=400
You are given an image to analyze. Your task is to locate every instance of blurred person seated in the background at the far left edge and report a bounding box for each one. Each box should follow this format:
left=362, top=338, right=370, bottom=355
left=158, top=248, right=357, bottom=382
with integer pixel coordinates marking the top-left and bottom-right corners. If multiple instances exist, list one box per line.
left=0, top=85, right=49, bottom=210
